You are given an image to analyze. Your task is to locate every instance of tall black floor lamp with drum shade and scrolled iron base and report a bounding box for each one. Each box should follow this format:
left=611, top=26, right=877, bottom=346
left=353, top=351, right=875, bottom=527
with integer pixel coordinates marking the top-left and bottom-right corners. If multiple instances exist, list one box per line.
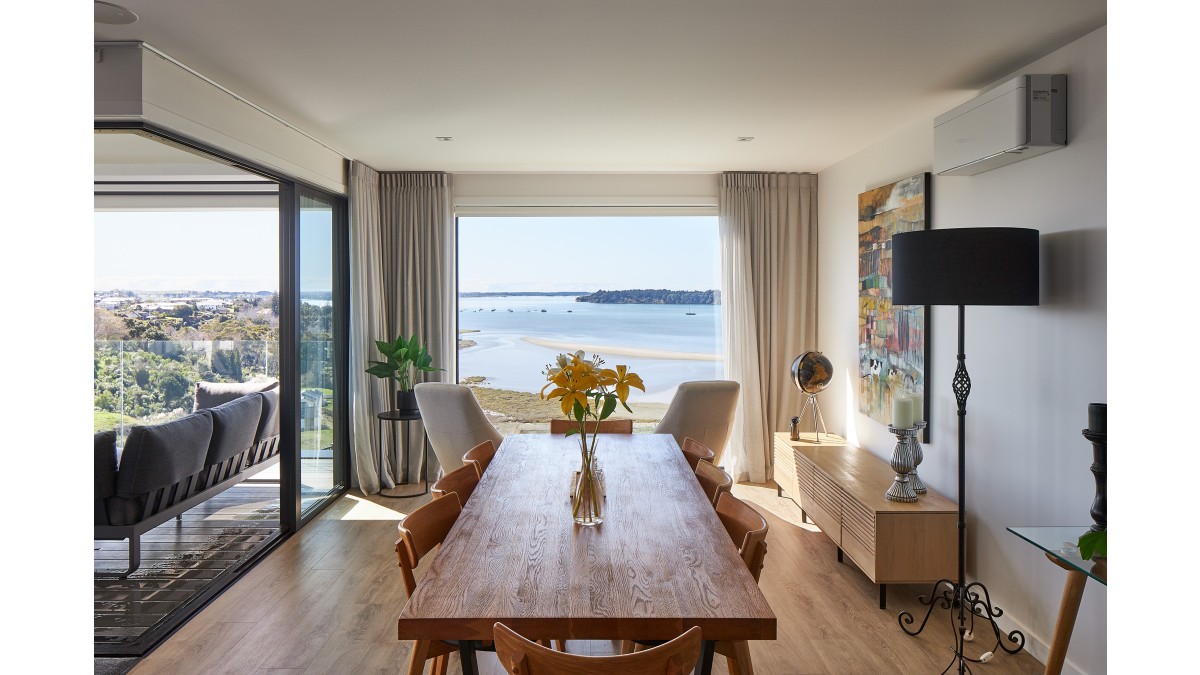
left=892, top=227, right=1038, bottom=674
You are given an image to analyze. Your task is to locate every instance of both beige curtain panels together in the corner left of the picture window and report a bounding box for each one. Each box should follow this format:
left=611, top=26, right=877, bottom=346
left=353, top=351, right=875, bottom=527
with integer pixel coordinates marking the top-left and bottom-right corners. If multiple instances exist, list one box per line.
left=349, top=162, right=458, bottom=494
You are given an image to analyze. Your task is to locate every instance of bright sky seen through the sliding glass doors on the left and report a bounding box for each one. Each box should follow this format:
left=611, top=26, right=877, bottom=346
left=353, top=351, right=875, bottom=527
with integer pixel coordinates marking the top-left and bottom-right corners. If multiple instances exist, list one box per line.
left=92, top=209, right=332, bottom=292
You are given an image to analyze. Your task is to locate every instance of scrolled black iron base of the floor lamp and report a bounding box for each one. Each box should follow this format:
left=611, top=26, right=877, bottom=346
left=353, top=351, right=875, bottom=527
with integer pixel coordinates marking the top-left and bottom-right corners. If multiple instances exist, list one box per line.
left=898, top=579, right=1025, bottom=675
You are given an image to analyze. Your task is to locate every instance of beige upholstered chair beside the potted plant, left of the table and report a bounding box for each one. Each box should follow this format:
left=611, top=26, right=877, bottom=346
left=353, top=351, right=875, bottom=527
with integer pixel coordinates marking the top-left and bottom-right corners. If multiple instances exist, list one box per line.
left=413, top=382, right=504, bottom=473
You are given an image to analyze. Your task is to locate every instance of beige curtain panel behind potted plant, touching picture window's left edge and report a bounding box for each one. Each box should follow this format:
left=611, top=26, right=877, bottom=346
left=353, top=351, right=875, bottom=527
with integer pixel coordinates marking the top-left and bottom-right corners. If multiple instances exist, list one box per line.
left=379, top=172, right=458, bottom=480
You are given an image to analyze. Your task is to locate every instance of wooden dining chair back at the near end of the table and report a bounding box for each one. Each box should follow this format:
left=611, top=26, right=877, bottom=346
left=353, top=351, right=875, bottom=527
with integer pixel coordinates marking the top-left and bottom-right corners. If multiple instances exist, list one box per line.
left=492, top=622, right=701, bottom=675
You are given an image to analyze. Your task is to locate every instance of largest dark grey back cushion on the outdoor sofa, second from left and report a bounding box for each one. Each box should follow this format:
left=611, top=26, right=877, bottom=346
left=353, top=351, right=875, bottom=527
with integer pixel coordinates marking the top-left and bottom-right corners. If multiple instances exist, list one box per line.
left=116, top=401, right=212, bottom=497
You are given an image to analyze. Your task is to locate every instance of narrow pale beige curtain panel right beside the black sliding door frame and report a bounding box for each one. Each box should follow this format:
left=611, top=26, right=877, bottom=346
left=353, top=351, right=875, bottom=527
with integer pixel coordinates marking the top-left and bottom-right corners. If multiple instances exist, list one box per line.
left=349, top=162, right=391, bottom=494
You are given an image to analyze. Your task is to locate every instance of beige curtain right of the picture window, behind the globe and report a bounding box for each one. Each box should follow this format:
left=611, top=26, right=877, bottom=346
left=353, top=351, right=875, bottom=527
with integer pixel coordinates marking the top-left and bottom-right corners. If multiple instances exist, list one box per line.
left=719, top=173, right=817, bottom=483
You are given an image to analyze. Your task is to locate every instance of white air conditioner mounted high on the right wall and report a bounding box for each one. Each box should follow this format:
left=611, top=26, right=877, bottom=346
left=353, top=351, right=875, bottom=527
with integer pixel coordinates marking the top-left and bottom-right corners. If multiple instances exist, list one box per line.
left=934, top=74, right=1067, bottom=175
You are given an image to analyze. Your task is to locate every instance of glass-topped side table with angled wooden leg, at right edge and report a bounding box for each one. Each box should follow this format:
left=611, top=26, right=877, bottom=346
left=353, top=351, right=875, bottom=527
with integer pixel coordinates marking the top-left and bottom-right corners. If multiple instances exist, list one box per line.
left=1008, top=525, right=1109, bottom=675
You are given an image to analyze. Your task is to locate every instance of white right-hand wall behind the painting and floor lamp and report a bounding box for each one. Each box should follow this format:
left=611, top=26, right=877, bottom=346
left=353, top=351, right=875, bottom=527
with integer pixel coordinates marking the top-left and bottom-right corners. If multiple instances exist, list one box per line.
left=817, top=28, right=1104, bottom=675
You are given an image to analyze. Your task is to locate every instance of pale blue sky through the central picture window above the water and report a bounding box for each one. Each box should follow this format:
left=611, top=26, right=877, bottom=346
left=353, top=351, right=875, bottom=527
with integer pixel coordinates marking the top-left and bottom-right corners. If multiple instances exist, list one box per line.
left=458, top=216, right=720, bottom=293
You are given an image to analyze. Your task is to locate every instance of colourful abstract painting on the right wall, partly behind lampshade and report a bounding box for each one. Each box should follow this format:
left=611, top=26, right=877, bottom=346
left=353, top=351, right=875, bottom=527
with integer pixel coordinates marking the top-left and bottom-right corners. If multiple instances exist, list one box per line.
left=858, top=173, right=930, bottom=427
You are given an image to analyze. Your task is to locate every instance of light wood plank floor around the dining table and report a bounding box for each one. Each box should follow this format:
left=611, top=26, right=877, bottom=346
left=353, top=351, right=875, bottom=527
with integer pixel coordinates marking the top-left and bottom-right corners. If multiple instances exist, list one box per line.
left=132, top=485, right=1043, bottom=675
